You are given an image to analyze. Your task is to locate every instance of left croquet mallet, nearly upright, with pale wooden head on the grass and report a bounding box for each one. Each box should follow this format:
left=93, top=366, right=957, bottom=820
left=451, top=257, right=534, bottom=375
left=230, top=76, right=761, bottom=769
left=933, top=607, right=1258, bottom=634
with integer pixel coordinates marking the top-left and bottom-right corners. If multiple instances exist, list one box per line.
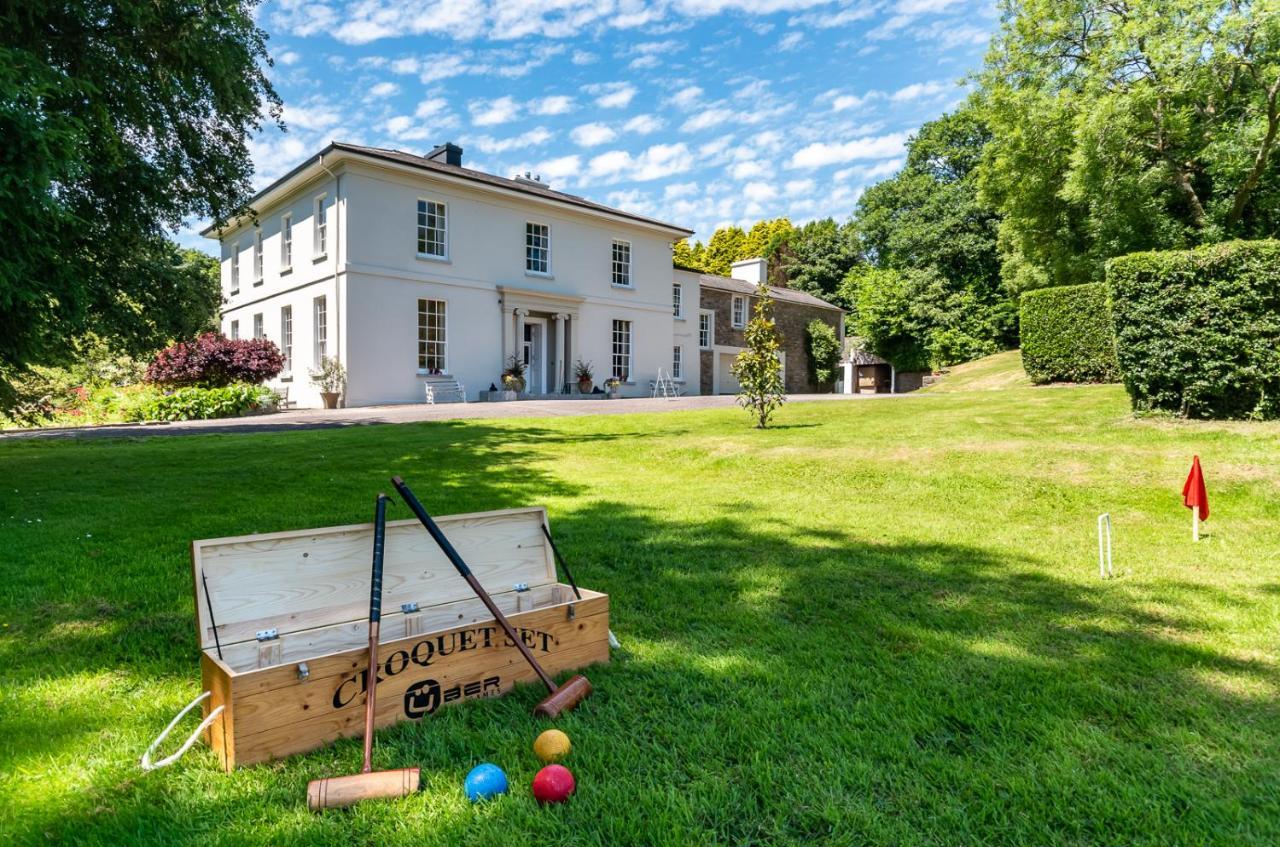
left=307, top=493, right=421, bottom=811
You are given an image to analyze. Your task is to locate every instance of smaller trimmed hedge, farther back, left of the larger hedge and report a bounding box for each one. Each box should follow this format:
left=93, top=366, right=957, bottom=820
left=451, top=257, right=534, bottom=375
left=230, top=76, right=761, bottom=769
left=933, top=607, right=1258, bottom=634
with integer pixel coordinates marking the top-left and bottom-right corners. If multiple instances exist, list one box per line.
left=1019, top=283, right=1120, bottom=383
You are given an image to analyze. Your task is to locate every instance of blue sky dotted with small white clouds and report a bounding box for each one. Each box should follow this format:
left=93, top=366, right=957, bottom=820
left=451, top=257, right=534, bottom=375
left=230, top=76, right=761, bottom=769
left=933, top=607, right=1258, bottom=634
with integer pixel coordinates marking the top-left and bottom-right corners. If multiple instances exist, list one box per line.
left=183, top=0, right=997, bottom=249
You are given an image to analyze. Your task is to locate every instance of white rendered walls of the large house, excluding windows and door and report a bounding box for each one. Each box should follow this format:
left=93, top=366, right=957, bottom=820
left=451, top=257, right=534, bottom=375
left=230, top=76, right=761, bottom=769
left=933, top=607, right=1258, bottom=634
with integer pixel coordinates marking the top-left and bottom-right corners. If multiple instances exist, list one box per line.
left=221, top=157, right=699, bottom=407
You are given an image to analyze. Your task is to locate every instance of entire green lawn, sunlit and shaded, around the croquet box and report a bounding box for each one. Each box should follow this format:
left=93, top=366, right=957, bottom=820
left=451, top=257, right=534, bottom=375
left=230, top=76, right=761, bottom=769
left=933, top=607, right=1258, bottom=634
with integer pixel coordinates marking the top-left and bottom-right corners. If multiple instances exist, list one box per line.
left=0, top=372, right=1280, bottom=846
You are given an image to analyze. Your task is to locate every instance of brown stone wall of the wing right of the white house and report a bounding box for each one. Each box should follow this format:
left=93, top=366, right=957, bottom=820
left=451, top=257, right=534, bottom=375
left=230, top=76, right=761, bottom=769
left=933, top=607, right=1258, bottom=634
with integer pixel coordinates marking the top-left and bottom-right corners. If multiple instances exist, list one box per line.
left=700, top=285, right=842, bottom=394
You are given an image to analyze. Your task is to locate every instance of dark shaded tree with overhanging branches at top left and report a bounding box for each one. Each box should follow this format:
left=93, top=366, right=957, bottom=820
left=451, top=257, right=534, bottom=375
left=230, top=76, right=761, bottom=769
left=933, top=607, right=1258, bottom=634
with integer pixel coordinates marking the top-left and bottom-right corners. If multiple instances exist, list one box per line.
left=0, top=0, right=279, bottom=371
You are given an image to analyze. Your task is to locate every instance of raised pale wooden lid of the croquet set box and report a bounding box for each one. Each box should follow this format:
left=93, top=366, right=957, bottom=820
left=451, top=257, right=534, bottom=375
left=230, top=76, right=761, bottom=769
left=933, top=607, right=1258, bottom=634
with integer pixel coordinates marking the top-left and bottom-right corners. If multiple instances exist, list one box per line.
left=191, top=507, right=556, bottom=650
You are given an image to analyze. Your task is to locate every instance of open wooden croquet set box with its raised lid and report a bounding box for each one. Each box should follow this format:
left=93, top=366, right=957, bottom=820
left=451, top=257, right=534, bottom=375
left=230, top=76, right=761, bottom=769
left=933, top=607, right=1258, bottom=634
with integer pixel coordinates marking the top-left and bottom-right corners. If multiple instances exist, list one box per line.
left=191, top=508, right=609, bottom=770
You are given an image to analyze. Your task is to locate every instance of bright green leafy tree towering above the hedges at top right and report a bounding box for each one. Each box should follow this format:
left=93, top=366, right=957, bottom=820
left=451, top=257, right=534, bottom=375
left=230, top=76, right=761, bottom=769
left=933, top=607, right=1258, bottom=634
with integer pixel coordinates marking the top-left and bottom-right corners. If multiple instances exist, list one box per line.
left=979, top=0, right=1280, bottom=289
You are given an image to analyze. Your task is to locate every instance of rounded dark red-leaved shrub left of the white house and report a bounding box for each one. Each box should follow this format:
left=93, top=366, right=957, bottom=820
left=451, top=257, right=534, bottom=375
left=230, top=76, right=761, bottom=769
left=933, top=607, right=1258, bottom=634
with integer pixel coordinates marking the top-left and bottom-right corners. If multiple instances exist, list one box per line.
left=147, top=333, right=284, bottom=388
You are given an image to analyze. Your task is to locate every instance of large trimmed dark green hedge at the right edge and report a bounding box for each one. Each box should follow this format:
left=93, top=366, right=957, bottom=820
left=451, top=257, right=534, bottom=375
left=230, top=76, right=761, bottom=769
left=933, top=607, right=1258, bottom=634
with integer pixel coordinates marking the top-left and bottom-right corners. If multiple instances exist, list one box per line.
left=1107, top=241, right=1280, bottom=418
